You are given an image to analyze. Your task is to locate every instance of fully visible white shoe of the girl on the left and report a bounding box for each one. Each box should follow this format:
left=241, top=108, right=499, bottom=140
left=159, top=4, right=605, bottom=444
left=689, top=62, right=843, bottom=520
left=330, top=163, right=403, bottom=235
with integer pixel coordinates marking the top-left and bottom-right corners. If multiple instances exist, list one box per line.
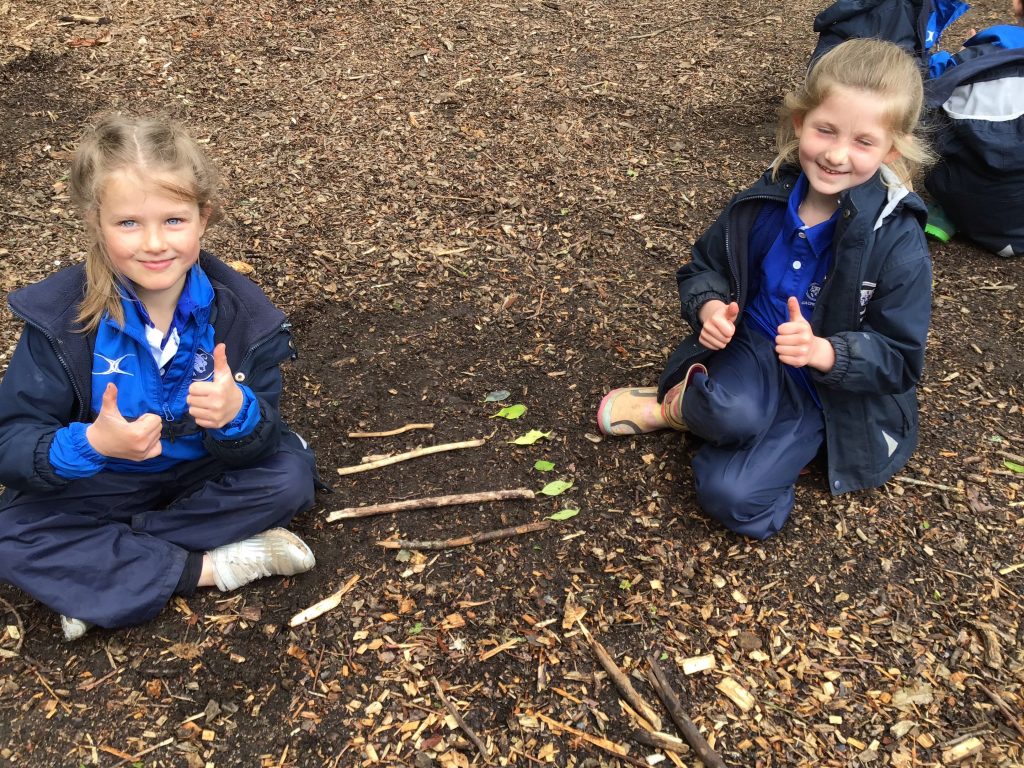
left=207, top=528, right=316, bottom=592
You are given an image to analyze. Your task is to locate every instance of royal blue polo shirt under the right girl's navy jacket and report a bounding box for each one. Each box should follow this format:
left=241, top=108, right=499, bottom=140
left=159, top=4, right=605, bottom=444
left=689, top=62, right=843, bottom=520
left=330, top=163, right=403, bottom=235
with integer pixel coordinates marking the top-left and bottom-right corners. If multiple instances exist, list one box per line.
left=743, top=174, right=839, bottom=408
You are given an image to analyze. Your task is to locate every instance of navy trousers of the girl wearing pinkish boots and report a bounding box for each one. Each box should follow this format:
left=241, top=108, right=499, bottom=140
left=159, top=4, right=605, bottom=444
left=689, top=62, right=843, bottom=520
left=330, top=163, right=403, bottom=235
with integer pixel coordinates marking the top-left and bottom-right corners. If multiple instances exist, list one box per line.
left=683, top=322, right=824, bottom=539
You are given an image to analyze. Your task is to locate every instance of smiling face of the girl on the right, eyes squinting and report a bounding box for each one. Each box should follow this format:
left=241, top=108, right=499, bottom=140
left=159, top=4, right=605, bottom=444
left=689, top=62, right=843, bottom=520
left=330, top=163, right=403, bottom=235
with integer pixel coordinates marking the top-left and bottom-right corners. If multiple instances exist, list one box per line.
left=793, top=86, right=899, bottom=205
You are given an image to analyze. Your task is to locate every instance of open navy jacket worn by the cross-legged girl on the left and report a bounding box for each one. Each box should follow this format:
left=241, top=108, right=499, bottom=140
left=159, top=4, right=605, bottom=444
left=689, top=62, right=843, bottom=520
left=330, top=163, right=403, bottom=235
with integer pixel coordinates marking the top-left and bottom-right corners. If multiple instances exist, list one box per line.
left=0, top=252, right=313, bottom=490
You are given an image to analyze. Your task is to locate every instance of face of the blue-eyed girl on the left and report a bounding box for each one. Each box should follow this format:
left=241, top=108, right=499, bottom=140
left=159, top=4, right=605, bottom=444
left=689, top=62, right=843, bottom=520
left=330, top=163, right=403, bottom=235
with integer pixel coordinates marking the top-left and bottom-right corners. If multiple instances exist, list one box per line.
left=99, top=170, right=209, bottom=306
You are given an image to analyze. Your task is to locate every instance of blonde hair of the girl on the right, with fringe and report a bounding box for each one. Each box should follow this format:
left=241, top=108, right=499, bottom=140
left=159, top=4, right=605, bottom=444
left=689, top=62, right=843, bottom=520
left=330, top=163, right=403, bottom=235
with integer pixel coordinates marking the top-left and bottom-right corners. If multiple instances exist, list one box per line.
left=771, top=38, right=933, bottom=186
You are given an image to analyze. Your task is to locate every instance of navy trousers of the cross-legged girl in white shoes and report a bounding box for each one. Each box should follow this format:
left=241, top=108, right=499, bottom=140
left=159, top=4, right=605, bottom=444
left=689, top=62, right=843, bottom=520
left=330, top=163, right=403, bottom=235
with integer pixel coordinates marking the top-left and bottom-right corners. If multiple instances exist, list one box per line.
left=0, top=451, right=314, bottom=627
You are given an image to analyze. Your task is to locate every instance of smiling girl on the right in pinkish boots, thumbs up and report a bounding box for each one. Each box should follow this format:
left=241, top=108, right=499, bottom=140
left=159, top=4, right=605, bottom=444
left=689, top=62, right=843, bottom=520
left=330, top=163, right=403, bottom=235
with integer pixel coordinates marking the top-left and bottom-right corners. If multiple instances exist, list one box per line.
left=597, top=39, right=932, bottom=539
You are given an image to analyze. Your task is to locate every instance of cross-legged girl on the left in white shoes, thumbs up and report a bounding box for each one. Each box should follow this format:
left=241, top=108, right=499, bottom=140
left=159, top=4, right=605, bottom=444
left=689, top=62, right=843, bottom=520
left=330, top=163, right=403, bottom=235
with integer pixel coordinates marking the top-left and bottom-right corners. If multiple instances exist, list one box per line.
left=0, top=117, right=315, bottom=640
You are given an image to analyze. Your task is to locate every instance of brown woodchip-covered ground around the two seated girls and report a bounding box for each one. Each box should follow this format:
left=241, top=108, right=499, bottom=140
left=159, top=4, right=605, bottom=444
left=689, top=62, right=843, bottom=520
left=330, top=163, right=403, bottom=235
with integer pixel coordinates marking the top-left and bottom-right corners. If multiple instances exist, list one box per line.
left=0, top=0, right=1024, bottom=768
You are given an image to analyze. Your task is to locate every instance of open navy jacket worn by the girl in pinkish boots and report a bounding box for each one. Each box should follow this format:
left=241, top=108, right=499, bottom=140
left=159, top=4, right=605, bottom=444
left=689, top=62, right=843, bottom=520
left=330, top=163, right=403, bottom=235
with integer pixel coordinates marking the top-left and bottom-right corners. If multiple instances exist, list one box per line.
left=658, top=166, right=932, bottom=494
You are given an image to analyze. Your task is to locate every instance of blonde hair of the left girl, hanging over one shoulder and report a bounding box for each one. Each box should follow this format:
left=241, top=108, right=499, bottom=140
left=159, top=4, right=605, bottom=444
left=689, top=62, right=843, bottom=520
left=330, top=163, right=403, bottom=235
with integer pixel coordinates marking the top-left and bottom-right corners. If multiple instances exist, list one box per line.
left=69, top=115, right=219, bottom=331
